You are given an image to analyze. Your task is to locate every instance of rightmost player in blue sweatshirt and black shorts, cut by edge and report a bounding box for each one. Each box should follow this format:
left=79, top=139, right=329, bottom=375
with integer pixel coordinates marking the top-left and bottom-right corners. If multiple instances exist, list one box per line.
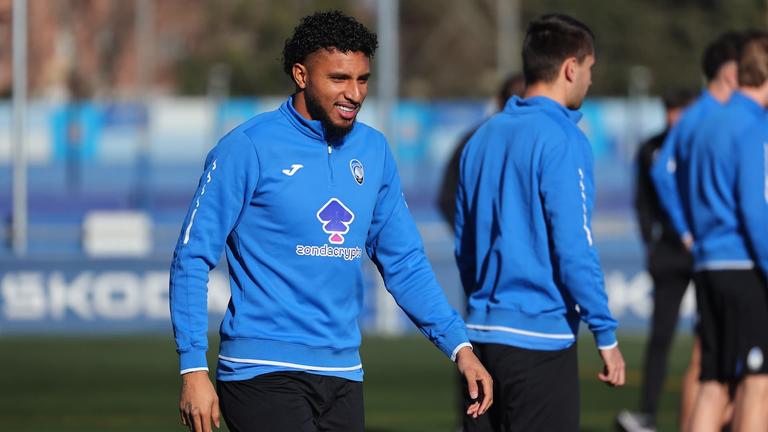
left=656, top=32, right=768, bottom=432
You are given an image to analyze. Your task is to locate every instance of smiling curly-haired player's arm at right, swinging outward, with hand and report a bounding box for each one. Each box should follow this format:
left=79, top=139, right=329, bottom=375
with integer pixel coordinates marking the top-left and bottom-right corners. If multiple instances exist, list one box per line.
left=366, top=138, right=493, bottom=416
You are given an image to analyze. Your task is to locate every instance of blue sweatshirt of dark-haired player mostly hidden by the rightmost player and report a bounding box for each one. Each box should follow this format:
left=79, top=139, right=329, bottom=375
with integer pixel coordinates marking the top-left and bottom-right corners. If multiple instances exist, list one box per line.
left=651, top=90, right=723, bottom=243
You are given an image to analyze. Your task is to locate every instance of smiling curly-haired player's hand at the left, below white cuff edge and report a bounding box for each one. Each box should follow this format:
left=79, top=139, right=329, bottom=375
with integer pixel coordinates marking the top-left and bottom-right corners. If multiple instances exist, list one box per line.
left=179, top=371, right=221, bottom=432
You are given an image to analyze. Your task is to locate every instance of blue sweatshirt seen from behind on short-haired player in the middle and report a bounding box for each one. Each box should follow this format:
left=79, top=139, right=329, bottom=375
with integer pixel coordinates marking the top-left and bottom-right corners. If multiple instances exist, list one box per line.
left=455, top=97, right=616, bottom=350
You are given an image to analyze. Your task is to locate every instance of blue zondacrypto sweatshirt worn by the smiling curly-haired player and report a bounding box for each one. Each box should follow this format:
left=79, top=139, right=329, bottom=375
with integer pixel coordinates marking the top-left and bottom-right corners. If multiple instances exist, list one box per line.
left=170, top=99, right=468, bottom=380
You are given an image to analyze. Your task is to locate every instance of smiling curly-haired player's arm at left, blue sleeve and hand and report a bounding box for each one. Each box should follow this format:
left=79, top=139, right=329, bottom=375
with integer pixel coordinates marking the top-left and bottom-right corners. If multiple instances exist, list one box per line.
left=169, top=133, right=258, bottom=431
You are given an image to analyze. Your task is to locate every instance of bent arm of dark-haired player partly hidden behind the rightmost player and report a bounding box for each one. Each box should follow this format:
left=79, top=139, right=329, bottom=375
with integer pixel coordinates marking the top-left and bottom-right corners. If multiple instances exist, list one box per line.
left=651, top=127, right=694, bottom=250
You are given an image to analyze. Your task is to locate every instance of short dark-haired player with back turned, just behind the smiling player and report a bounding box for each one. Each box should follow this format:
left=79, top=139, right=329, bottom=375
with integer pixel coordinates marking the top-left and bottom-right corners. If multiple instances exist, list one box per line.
left=455, top=14, right=625, bottom=431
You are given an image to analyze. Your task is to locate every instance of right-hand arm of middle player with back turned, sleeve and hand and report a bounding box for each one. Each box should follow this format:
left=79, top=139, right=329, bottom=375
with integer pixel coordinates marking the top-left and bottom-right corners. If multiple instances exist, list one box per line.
left=539, top=140, right=624, bottom=385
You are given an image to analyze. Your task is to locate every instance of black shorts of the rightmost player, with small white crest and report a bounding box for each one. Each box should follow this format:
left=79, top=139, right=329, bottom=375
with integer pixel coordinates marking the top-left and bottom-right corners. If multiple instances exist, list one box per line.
left=694, top=269, right=768, bottom=383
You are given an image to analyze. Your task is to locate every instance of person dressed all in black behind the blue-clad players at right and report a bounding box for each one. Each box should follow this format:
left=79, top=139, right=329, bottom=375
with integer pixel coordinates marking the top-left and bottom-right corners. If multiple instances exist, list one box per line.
left=616, top=89, right=695, bottom=432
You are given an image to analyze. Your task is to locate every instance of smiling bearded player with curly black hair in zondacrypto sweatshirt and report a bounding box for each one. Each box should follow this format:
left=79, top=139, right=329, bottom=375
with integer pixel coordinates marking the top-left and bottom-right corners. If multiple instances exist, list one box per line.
left=170, top=12, right=492, bottom=432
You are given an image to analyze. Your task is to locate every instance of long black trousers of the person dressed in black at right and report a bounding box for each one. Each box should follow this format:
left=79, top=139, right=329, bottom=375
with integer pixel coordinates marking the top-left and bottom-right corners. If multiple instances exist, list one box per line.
left=640, top=246, right=693, bottom=419
